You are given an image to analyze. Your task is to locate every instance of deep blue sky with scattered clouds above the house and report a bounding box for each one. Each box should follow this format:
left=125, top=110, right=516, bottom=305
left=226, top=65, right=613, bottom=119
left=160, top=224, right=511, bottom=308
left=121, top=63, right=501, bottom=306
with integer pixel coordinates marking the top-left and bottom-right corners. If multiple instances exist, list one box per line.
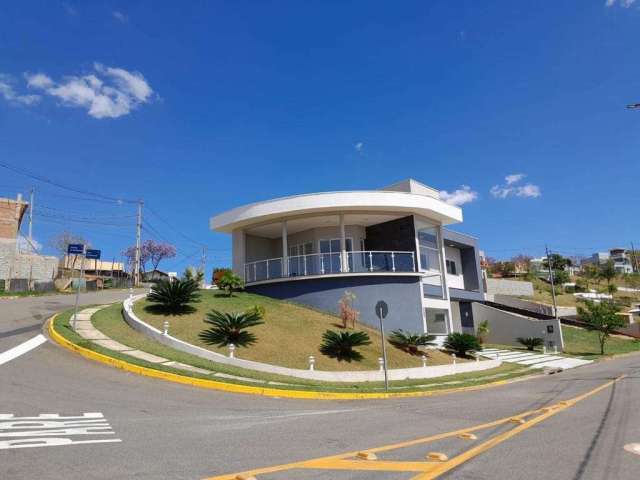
left=0, top=0, right=640, bottom=270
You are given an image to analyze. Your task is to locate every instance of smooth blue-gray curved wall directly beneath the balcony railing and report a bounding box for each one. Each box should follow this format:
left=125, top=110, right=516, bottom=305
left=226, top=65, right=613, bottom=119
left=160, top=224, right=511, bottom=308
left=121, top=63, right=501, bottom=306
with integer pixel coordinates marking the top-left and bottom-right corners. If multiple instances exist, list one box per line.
left=246, top=275, right=424, bottom=332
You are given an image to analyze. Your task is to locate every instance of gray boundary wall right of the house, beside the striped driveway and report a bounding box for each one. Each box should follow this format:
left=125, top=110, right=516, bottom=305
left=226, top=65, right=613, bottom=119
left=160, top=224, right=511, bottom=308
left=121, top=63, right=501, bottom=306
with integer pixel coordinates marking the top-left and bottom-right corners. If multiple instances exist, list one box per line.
left=472, top=302, right=563, bottom=350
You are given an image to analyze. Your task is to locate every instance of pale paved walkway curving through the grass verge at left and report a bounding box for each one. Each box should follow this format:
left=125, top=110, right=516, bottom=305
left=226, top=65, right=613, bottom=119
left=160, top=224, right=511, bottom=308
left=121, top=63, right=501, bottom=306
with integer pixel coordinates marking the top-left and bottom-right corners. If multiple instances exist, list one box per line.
left=70, top=305, right=290, bottom=385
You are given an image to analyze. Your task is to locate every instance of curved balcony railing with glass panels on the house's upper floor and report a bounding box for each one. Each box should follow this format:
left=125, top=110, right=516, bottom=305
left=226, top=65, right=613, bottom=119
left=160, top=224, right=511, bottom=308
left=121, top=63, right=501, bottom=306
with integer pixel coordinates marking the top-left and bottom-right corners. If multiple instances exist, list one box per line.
left=244, top=251, right=416, bottom=284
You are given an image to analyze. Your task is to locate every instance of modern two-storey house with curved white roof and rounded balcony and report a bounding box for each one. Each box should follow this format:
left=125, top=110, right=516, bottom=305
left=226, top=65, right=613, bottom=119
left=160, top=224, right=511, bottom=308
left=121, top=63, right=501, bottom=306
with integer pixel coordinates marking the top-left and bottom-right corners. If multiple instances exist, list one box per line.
left=210, top=179, right=484, bottom=336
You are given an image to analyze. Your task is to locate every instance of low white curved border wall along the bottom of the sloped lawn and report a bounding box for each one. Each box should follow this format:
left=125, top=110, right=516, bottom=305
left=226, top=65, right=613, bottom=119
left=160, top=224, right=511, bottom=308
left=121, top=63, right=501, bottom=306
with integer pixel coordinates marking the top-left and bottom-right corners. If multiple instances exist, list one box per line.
left=123, top=294, right=502, bottom=382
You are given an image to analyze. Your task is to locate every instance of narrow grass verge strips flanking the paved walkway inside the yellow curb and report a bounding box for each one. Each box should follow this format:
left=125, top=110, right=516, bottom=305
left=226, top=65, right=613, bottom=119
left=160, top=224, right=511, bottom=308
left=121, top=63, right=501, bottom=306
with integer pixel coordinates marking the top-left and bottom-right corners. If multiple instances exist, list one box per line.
left=50, top=304, right=533, bottom=392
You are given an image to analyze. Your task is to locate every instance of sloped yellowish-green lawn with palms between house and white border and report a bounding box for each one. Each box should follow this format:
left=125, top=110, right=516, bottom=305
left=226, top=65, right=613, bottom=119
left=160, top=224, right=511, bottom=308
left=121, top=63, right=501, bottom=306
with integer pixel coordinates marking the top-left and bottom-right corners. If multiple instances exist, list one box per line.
left=134, top=290, right=464, bottom=370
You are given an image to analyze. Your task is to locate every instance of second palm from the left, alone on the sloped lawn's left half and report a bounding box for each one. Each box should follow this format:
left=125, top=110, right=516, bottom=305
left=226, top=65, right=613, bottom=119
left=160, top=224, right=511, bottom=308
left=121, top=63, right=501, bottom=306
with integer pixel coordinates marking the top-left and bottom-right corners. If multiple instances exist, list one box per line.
left=199, top=310, right=264, bottom=347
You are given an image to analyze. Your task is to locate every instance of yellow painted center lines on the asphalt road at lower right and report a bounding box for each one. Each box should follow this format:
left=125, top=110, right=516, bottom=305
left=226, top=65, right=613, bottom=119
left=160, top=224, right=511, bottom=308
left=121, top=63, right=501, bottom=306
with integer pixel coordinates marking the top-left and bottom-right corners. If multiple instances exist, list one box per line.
left=203, top=375, right=625, bottom=480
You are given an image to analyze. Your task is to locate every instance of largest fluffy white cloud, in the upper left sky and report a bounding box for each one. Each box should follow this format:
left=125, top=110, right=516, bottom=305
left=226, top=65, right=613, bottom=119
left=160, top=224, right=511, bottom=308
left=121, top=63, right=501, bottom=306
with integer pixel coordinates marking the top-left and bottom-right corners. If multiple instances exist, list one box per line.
left=25, top=63, right=153, bottom=118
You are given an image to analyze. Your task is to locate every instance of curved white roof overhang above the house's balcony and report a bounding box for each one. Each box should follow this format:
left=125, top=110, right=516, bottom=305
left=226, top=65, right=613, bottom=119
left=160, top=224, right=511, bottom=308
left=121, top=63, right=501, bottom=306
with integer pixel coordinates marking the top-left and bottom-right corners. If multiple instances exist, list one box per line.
left=210, top=190, right=462, bottom=232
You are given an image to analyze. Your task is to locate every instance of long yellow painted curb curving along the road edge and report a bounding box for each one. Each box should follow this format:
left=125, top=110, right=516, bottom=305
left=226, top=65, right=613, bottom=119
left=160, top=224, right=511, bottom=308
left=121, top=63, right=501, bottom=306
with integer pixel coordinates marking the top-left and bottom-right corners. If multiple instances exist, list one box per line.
left=47, top=314, right=528, bottom=400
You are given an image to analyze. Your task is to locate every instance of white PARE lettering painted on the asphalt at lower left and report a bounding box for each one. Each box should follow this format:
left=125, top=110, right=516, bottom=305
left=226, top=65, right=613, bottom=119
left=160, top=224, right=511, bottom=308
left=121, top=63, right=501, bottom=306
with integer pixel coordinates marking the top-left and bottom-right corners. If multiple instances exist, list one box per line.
left=0, top=412, right=122, bottom=450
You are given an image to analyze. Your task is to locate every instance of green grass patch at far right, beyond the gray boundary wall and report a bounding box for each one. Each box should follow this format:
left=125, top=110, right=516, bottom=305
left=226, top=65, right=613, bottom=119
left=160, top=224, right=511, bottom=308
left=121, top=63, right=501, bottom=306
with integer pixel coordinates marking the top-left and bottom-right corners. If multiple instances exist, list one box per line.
left=562, top=325, right=640, bottom=358
